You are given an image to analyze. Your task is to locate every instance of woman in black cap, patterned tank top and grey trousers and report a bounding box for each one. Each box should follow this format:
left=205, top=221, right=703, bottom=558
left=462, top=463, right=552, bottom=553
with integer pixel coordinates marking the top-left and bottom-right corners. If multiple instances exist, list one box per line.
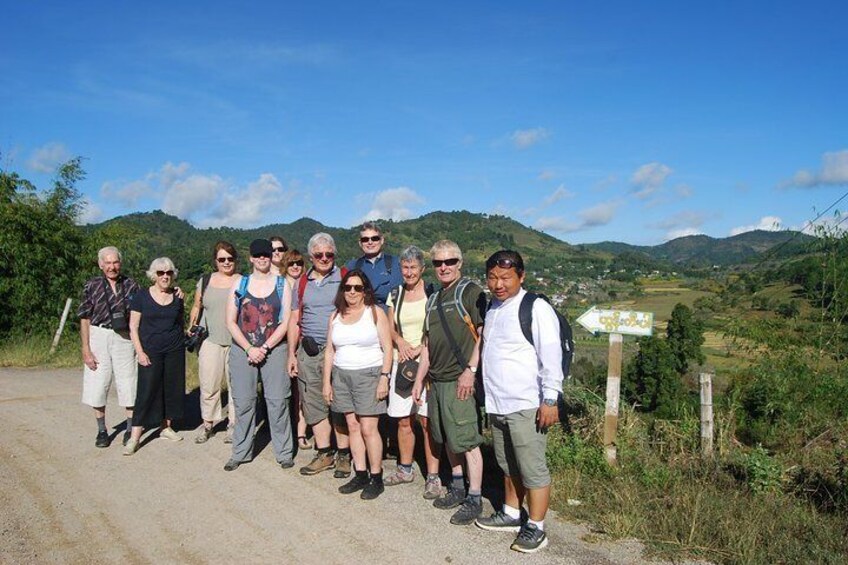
left=224, top=239, right=294, bottom=471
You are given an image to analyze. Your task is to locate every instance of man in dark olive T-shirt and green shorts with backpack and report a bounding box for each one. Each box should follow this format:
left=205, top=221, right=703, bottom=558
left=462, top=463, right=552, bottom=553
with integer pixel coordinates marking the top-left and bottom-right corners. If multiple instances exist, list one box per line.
left=412, top=240, right=486, bottom=525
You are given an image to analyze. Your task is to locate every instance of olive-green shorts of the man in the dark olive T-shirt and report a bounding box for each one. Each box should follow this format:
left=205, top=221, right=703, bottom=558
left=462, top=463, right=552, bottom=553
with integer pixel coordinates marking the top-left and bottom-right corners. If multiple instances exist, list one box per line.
left=427, top=381, right=483, bottom=453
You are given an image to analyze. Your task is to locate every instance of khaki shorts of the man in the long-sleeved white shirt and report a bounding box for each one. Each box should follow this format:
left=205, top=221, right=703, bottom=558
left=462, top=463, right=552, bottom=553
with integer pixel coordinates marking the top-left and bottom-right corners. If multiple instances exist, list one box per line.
left=489, top=408, right=551, bottom=489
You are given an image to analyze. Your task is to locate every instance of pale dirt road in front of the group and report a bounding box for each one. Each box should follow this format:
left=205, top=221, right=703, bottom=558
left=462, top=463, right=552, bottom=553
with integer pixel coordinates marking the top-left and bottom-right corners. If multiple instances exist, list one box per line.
left=0, top=369, right=652, bottom=565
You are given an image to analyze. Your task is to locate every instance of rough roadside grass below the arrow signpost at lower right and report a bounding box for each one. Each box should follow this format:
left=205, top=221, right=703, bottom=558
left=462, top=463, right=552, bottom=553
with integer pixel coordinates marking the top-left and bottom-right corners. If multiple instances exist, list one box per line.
left=548, top=387, right=848, bottom=564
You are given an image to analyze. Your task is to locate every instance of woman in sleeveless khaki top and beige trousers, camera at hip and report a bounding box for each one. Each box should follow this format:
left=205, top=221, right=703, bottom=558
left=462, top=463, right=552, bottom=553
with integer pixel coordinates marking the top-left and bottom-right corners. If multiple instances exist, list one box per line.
left=189, top=241, right=241, bottom=443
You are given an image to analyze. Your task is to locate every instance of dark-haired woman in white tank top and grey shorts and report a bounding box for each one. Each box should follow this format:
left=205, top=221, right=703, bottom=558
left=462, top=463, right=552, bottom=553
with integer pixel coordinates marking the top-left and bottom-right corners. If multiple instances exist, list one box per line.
left=323, top=269, right=392, bottom=500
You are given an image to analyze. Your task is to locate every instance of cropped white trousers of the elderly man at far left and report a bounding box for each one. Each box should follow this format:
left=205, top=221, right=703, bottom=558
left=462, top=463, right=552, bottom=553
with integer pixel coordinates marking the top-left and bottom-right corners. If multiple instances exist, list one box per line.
left=82, top=326, right=138, bottom=408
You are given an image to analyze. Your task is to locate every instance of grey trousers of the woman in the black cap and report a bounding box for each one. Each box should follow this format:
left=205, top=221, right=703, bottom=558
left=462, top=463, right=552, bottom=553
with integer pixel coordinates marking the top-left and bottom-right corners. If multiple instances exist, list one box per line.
left=230, top=343, right=294, bottom=463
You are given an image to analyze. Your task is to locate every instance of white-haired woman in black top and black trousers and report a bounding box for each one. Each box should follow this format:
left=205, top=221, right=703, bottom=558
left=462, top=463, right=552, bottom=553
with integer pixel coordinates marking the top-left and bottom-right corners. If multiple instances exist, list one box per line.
left=124, top=257, right=185, bottom=455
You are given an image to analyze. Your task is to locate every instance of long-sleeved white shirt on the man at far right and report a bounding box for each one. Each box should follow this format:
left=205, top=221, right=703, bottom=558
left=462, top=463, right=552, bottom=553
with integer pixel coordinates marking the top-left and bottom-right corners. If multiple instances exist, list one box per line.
left=483, top=288, right=563, bottom=415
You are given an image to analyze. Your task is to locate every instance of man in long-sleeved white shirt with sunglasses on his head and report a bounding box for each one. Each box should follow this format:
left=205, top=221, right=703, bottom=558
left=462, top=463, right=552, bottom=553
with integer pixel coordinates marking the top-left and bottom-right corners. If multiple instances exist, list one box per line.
left=475, top=250, right=563, bottom=553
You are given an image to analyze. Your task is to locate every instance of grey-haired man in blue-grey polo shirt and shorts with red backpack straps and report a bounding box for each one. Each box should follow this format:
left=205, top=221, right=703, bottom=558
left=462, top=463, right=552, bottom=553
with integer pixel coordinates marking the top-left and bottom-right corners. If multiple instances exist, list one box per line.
left=288, top=233, right=350, bottom=478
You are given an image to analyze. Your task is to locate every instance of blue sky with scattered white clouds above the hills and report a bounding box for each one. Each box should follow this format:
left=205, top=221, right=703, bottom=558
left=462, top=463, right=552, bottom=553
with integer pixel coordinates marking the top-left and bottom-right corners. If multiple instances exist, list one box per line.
left=0, top=1, right=848, bottom=244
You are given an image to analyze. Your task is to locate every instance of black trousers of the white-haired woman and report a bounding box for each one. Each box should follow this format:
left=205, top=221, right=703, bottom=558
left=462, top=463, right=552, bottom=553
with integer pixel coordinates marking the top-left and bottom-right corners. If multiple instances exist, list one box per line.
left=133, top=348, right=185, bottom=428
